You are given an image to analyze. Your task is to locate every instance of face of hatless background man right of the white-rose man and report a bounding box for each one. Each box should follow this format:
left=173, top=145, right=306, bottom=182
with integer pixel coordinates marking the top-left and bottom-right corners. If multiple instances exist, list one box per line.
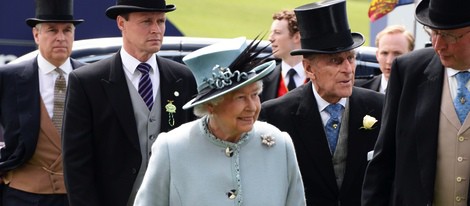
left=376, top=33, right=409, bottom=80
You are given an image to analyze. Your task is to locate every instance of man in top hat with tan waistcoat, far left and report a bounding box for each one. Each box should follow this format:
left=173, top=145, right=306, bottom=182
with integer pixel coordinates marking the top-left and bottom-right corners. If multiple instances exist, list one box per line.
left=0, top=0, right=83, bottom=206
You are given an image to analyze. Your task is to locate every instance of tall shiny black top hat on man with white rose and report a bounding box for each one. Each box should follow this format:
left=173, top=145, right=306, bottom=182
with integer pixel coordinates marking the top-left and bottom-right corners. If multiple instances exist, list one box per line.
left=290, top=0, right=364, bottom=55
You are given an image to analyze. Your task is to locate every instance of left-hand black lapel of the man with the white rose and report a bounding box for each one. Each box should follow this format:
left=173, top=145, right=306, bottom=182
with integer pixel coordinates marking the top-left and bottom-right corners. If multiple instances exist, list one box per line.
left=292, top=83, right=338, bottom=193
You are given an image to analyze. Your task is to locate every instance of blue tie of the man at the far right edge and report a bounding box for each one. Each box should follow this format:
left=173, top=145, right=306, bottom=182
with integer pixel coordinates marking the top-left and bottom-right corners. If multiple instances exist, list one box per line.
left=454, top=72, right=470, bottom=123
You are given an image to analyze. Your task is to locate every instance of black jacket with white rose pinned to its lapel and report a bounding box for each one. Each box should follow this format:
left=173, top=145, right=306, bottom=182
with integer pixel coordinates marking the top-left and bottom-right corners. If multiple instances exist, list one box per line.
left=260, top=82, right=384, bottom=206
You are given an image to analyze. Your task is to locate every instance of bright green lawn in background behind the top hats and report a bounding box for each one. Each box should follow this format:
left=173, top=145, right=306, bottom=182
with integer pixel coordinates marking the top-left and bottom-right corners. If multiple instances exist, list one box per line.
left=167, top=0, right=370, bottom=44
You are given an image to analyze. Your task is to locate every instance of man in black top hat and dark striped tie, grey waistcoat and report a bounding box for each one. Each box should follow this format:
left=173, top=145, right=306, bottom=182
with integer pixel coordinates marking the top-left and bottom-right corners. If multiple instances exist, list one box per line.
left=63, top=0, right=197, bottom=206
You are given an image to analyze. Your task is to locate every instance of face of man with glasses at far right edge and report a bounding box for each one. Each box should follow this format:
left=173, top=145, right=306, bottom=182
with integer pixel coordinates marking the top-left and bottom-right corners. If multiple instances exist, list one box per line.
left=431, top=26, right=470, bottom=70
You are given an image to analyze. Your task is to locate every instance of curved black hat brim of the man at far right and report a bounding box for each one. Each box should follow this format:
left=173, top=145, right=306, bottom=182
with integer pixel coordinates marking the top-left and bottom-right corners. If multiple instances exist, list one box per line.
left=415, top=0, right=470, bottom=30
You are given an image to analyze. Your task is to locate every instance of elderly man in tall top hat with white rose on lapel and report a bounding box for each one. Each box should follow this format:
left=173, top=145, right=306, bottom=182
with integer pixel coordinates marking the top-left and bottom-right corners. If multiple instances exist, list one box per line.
left=260, top=0, right=384, bottom=206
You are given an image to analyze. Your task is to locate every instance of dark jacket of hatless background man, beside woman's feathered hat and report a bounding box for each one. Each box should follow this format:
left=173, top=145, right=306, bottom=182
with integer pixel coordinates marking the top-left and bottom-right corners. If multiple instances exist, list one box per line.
left=259, top=64, right=282, bottom=102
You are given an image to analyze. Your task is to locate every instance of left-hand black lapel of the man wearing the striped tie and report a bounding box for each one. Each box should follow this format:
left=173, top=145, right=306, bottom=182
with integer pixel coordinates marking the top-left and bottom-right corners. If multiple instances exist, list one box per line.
left=101, top=52, right=140, bottom=151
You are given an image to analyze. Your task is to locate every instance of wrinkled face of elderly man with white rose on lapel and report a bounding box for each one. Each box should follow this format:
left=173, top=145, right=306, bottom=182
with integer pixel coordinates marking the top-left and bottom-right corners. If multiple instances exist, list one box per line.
left=303, top=50, right=356, bottom=103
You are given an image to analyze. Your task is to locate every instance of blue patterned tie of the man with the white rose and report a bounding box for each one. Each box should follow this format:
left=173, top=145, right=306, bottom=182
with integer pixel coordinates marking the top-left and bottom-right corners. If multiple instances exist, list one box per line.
left=325, top=103, right=342, bottom=154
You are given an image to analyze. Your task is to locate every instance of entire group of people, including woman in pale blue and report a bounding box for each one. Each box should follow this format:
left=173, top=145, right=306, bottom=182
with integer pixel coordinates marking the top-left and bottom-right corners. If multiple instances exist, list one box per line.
left=0, top=0, right=470, bottom=206
